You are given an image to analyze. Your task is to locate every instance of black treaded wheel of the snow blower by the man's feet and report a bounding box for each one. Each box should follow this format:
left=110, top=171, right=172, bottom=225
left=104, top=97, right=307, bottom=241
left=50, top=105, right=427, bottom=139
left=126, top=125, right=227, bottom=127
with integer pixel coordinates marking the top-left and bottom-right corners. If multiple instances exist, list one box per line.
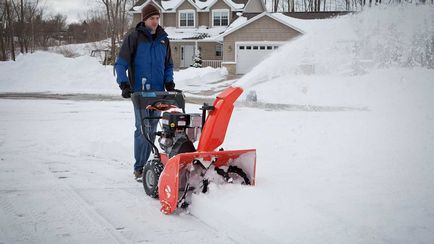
left=143, top=159, right=164, bottom=198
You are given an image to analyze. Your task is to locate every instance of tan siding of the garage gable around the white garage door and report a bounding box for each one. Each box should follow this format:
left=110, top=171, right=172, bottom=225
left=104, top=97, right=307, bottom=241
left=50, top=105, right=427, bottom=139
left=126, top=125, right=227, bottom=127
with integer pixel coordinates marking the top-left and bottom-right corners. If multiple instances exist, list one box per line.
left=223, top=15, right=301, bottom=62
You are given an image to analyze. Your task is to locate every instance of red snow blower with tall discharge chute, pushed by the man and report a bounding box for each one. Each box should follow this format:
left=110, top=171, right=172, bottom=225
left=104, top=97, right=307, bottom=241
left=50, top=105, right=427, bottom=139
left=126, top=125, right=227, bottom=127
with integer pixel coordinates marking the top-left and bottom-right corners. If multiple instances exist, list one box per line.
left=132, top=87, right=256, bottom=214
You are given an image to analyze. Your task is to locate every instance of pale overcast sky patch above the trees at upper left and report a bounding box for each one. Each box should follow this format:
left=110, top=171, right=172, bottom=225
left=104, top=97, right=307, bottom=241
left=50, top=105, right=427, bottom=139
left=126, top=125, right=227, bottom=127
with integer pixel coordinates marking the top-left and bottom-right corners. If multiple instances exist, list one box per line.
left=40, top=0, right=99, bottom=23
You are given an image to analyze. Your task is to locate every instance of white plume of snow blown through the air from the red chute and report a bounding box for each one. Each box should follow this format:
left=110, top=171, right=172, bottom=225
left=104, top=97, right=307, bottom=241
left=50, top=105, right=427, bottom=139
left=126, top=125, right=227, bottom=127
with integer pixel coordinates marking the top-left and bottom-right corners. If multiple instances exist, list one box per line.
left=239, top=5, right=434, bottom=88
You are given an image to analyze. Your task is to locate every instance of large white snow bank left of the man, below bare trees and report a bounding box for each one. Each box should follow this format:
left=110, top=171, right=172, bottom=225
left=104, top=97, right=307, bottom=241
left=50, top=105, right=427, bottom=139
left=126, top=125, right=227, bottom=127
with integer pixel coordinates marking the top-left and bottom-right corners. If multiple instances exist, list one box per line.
left=0, top=51, right=119, bottom=94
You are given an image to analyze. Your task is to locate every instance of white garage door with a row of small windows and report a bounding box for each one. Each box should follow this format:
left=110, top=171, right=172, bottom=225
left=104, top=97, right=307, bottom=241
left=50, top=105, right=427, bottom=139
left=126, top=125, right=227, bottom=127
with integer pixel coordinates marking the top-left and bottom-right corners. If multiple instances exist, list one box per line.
left=236, top=43, right=279, bottom=74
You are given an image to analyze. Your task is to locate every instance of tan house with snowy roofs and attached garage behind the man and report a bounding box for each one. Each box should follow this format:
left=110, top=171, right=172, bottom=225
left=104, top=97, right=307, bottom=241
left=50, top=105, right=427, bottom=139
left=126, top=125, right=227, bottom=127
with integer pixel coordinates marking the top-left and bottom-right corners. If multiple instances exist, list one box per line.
left=131, top=0, right=302, bottom=74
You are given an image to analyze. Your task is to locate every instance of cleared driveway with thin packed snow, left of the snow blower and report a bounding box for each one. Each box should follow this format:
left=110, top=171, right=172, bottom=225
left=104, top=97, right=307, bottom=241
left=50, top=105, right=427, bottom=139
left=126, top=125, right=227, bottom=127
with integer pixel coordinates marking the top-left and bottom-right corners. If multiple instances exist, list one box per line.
left=0, top=100, right=233, bottom=243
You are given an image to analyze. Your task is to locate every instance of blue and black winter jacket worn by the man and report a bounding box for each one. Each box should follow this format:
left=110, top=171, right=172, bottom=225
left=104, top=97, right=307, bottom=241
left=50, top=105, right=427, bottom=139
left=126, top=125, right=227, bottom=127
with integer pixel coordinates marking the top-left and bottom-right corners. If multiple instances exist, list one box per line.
left=115, top=22, right=173, bottom=91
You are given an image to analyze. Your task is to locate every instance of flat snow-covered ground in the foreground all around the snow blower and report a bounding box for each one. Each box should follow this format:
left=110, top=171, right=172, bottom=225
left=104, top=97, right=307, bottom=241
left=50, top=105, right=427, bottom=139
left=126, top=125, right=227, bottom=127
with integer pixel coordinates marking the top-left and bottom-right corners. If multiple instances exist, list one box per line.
left=0, top=94, right=434, bottom=243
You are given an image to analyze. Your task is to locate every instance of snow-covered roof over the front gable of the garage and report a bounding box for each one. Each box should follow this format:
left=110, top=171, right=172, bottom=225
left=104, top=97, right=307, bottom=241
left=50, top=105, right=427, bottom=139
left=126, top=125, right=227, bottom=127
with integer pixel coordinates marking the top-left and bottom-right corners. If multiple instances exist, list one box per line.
left=221, top=12, right=304, bottom=37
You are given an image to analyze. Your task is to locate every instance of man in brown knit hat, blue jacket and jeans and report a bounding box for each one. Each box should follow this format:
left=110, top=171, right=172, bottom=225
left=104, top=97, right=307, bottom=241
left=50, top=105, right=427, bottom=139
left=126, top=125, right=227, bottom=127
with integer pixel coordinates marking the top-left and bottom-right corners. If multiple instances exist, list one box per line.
left=115, top=4, right=175, bottom=180
